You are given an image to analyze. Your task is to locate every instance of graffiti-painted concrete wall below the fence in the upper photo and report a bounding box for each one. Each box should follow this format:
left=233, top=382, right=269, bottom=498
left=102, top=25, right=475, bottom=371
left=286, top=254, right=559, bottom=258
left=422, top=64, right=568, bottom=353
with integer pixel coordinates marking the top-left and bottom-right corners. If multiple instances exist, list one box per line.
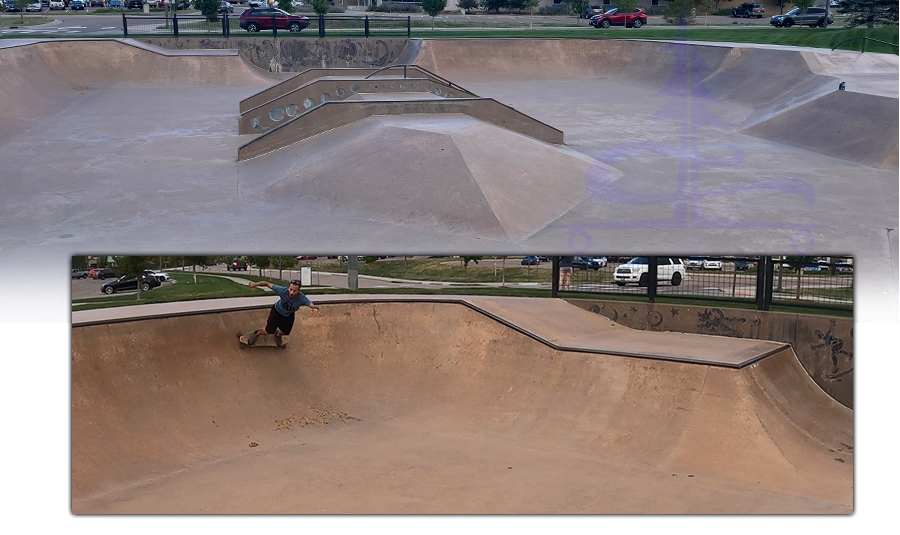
left=136, top=37, right=406, bottom=72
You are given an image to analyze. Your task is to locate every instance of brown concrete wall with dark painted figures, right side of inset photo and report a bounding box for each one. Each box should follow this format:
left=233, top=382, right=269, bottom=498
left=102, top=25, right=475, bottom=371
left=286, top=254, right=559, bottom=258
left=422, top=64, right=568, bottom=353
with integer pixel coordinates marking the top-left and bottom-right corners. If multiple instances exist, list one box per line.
left=567, top=299, right=853, bottom=409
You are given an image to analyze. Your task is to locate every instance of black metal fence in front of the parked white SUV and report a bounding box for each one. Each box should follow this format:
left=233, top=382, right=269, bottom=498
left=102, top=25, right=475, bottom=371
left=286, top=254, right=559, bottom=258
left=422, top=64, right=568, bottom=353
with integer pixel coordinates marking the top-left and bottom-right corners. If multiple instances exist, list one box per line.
left=552, top=256, right=853, bottom=310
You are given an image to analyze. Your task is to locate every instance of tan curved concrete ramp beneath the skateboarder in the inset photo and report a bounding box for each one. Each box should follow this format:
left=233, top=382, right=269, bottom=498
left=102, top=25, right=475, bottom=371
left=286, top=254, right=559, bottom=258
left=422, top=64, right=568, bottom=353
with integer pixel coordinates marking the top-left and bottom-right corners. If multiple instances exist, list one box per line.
left=72, top=296, right=853, bottom=514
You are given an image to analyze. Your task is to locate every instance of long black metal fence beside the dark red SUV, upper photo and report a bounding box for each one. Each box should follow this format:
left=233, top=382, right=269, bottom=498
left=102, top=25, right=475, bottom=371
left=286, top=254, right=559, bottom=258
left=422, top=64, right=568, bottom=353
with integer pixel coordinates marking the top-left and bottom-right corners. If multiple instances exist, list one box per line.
left=122, top=13, right=411, bottom=38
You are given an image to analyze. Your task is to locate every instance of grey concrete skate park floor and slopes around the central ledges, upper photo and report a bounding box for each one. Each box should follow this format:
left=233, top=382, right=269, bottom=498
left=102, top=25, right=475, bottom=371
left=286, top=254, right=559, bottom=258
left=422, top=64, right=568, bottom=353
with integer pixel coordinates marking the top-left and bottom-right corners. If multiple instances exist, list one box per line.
left=0, top=39, right=898, bottom=321
